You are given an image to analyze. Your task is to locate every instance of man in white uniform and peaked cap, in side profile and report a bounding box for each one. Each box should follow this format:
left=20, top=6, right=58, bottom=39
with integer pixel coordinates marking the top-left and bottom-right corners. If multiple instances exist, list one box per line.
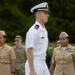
left=25, top=2, right=50, bottom=75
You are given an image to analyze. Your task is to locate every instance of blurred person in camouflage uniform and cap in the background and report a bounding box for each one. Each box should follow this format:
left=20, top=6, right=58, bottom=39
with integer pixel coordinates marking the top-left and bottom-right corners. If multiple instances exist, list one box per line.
left=13, top=35, right=26, bottom=75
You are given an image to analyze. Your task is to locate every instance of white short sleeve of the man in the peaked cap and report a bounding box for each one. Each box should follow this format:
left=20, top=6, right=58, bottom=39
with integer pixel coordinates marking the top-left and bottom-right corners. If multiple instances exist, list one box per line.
left=26, top=30, right=38, bottom=48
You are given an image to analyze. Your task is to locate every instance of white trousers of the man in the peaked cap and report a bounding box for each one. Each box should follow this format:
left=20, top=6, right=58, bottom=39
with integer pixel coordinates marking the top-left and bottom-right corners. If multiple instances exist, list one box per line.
left=25, top=59, right=50, bottom=75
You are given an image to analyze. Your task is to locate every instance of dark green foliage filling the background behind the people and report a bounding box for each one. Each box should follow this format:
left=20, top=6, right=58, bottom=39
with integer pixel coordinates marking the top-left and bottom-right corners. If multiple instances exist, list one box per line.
left=0, top=0, right=75, bottom=42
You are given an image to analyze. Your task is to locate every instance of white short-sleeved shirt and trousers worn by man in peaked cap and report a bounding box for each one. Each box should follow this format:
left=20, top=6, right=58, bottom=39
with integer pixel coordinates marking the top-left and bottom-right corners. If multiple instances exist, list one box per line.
left=25, top=21, right=50, bottom=75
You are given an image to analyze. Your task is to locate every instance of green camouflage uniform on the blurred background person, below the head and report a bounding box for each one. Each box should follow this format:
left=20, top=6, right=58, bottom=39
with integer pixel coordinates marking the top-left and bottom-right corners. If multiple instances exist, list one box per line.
left=13, top=45, right=26, bottom=75
